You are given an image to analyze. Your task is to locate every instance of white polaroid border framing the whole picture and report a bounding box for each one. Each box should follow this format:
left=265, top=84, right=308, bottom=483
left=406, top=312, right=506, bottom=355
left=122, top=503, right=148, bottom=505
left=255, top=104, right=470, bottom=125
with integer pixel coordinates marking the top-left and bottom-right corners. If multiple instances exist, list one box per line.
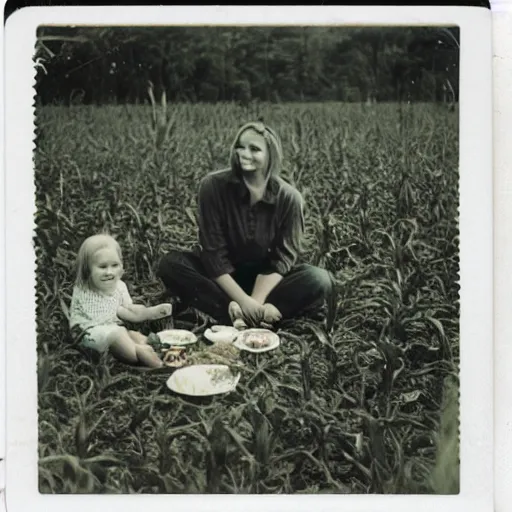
left=5, top=6, right=493, bottom=512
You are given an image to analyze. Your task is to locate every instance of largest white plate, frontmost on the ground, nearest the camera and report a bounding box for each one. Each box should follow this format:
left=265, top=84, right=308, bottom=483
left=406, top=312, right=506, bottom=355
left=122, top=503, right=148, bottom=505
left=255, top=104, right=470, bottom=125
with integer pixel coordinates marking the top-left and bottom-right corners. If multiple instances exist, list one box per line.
left=167, top=364, right=240, bottom=396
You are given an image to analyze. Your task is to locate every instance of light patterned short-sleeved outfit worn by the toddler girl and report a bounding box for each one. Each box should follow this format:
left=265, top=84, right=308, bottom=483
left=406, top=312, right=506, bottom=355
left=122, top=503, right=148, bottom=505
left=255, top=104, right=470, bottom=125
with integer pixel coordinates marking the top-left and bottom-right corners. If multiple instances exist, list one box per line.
left=69, top=280, right=133, bottom=352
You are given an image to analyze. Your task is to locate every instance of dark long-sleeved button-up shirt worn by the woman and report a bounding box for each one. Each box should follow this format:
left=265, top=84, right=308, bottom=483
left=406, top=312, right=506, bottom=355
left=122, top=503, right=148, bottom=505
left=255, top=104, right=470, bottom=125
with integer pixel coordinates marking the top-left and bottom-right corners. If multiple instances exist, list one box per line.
left=198, top=169, right=304, bottom=279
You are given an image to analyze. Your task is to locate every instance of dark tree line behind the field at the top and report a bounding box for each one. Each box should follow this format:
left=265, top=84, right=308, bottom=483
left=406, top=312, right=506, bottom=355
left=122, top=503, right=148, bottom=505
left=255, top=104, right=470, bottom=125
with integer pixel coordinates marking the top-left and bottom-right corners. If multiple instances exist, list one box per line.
left=34, top=26, right=459, bottom=105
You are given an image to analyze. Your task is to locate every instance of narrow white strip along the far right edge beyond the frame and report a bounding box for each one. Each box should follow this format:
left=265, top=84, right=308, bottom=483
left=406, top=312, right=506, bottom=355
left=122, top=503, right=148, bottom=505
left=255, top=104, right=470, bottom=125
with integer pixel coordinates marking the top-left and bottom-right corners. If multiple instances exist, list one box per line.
left=492, top=0, right=512, bottom=512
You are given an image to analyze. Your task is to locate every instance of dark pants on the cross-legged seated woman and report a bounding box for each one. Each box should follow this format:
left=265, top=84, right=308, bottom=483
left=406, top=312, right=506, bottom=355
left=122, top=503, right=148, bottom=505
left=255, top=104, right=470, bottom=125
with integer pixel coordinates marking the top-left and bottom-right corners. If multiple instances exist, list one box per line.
left=157, top=251, right=335, bottom=323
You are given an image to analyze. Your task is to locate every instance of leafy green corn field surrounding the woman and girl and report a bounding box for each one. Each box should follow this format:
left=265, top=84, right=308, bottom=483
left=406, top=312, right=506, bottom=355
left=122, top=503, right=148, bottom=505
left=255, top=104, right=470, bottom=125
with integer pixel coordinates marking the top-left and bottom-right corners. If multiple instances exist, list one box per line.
left=34, top=103, right=459, bottom=494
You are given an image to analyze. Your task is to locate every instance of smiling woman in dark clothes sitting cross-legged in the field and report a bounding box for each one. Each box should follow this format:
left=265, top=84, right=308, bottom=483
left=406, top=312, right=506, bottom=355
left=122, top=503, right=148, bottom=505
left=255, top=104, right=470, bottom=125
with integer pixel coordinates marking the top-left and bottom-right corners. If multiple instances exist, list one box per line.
left=157, top=122, right=334, bottom=327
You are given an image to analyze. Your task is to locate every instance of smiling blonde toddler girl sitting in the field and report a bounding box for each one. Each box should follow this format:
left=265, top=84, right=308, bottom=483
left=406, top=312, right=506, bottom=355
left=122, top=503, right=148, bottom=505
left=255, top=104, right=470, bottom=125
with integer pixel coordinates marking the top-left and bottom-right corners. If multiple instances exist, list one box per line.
left=70, top=235, right=172, bottom=368
